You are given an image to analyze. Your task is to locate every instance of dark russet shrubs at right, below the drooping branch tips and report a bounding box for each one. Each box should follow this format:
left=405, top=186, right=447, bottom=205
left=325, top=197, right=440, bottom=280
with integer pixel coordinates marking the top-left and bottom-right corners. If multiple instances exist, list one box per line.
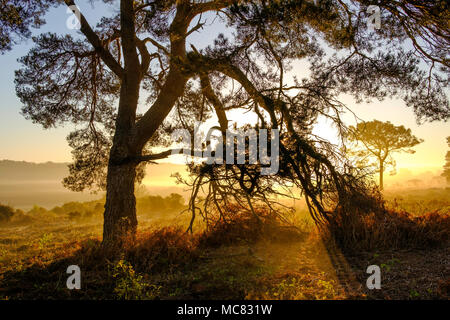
left=325, top=191, right=450, bottom=250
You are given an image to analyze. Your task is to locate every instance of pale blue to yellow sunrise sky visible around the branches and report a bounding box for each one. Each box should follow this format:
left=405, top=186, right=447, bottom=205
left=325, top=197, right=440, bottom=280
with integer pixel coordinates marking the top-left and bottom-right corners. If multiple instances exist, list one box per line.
left=0, top=1, right=450, bottom=175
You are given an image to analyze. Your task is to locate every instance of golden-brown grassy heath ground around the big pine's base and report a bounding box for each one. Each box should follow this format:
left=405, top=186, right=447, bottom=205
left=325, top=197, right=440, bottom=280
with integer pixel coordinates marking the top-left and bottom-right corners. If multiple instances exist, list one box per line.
left=0, top=189, right=450, bottom=299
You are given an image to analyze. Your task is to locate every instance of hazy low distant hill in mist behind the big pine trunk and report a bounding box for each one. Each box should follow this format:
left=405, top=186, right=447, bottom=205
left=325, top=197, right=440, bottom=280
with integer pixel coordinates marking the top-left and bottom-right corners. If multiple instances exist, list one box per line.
left=0, top=160, right=187, bottom=210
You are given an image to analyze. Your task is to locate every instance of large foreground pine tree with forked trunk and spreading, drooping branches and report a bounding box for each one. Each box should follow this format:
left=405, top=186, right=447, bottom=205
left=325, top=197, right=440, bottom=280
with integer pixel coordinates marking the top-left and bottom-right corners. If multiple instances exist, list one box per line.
left=5, top=0, right=450, bottom=244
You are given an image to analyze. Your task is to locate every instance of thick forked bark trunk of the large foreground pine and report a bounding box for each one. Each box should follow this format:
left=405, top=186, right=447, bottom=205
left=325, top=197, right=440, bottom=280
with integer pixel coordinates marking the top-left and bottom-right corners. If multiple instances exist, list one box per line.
left=99, top=1, right=191, bottom=247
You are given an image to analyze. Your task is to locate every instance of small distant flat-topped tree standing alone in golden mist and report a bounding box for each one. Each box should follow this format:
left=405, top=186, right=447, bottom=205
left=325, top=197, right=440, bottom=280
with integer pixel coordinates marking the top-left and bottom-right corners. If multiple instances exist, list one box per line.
left=347, top=120, right=423, bottom=190
